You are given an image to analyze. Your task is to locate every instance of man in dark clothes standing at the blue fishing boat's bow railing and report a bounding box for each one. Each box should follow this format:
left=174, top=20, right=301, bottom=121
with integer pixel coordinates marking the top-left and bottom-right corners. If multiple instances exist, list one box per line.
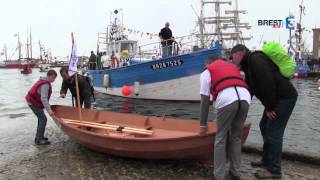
left=159, top=22, right=174, bottom=57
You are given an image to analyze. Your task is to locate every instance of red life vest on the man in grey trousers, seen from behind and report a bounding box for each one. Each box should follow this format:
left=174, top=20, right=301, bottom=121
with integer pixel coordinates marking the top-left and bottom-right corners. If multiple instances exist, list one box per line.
left=207, top=60, right=249, bottom=100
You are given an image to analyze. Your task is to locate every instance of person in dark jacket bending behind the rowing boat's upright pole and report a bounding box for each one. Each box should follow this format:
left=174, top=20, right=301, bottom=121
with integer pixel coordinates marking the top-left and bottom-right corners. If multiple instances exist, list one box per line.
left=60, top=67, right=93, bottom=109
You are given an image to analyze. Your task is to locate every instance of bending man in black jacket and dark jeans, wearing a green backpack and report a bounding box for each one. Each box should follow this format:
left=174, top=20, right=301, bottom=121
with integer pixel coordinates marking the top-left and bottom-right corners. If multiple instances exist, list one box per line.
left=231, top=45, right=298, bottom=178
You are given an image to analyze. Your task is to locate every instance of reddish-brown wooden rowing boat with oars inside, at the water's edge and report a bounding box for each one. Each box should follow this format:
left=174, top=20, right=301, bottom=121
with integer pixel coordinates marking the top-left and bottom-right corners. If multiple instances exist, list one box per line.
left=52, top=105, right=250, bottom=160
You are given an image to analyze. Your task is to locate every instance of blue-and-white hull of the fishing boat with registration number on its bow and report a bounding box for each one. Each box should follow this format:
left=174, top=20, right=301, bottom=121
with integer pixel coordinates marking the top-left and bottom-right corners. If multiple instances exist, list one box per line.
left=88, top=48, right=221, bottom=101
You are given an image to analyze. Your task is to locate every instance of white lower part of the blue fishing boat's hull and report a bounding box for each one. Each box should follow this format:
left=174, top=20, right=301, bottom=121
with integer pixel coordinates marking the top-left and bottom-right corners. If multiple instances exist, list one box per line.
left=95, top=74, right=200, bottom=101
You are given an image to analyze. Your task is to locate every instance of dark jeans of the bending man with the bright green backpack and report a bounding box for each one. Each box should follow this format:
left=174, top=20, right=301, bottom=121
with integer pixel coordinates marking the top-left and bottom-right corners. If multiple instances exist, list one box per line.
left=260, top=97, right=297, bottom=174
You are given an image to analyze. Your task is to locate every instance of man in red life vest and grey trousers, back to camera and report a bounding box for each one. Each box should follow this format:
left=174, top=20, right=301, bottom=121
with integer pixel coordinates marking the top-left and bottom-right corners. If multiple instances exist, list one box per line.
left=200, top=57, right=251, bottom=180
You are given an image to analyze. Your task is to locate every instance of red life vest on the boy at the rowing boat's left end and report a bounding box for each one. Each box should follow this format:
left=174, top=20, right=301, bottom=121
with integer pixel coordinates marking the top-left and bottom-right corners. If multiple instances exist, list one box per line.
left=26, top=79, right=52, bottom=108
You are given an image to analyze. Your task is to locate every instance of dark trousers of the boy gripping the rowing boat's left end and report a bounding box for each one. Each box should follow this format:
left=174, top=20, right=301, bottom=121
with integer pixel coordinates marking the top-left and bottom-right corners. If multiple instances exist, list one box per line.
left=29, top=105, right=47, bottom=139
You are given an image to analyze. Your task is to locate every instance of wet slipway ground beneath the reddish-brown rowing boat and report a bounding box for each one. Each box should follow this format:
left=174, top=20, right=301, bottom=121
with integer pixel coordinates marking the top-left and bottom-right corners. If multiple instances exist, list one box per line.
left=0, top=116, right=320, bottom=180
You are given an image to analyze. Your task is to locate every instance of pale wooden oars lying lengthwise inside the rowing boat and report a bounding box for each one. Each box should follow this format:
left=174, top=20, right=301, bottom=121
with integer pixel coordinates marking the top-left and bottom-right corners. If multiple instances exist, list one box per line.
left=61, top=118, right=153, bottom=135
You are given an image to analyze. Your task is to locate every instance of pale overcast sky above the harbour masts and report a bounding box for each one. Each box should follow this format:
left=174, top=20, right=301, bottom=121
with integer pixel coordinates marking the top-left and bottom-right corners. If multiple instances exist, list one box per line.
left=0, top=0, right=320, bottom=60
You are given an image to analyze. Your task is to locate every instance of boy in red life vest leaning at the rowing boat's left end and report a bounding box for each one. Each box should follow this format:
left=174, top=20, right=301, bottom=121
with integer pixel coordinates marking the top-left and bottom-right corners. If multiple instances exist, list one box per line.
left=25, top=70, right=57, bottom=145
